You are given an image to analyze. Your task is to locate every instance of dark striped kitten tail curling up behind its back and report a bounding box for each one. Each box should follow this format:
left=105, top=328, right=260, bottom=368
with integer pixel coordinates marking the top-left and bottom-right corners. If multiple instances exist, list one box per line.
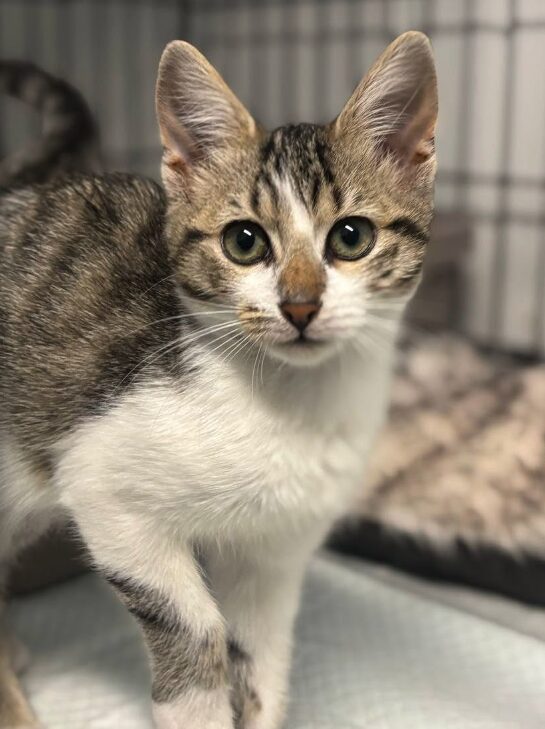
left=0, top=60, right=100, bottom=188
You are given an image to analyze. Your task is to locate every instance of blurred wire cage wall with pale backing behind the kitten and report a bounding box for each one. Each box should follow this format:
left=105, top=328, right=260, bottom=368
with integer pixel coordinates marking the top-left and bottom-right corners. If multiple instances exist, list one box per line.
left=0, top=0, right=545, bottom=355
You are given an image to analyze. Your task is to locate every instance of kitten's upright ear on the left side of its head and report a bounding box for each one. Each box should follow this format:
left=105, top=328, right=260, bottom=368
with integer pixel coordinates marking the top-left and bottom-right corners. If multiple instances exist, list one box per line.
left=156, top=41, right=256, bottom=192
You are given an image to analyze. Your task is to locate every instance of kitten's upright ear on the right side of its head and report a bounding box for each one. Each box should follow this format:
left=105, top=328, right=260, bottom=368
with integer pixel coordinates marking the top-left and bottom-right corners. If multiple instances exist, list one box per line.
left=334, top=31, right=437, bottom=165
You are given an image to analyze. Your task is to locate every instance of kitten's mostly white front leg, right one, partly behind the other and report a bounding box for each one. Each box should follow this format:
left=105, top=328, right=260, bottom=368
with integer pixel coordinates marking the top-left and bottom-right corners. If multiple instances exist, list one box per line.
left=209, top=546, right=311, bottom=729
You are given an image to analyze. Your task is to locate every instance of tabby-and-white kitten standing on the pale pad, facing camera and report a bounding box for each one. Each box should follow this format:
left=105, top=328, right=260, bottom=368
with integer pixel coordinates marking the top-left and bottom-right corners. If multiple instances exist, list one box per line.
left=0, top=32, right=437, bottom=729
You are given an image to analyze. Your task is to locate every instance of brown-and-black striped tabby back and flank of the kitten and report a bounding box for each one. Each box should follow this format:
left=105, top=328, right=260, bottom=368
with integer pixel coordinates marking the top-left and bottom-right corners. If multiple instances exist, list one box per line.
left=0, top=174, right=182, bottom=456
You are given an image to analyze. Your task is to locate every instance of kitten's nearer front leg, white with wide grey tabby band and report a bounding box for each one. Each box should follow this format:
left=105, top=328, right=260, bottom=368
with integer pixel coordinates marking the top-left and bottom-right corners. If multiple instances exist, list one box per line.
left=65, top=491, right=233, bottom=729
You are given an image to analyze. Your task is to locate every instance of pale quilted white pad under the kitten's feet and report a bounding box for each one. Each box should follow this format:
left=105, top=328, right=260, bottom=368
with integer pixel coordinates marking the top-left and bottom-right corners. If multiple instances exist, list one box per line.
left=10, top=556, right=545, bottom=729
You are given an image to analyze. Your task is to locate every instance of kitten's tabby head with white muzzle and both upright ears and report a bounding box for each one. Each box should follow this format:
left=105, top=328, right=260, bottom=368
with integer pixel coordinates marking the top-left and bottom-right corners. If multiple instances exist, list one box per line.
left=157, top=32, right=437, bottom=365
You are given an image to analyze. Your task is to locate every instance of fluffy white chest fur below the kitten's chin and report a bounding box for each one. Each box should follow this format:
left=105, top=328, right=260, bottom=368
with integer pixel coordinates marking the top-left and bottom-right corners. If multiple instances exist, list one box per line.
left=58, top=346, right=389, bottom=540
